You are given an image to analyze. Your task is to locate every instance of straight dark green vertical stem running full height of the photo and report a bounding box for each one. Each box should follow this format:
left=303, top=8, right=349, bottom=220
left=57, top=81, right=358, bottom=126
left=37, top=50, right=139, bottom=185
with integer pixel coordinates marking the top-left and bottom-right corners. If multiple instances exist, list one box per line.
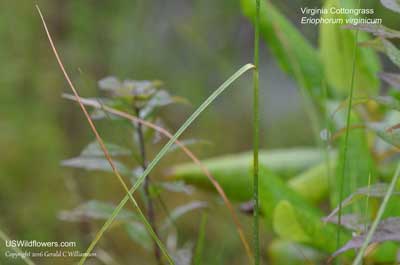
left=253, top=0, right=260, bottom=265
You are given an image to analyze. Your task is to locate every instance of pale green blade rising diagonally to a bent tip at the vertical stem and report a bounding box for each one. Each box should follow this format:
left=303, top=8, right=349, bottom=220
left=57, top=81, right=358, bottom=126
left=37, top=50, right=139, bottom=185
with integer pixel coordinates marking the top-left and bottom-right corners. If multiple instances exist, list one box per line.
left=79, top=64, right=254, bottom=265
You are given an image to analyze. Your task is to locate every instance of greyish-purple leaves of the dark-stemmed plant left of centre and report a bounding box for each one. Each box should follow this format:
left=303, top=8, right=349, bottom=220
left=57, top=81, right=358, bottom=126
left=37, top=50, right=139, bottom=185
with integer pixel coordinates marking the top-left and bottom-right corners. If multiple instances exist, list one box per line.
left=59, top=77, right=207, bottom=265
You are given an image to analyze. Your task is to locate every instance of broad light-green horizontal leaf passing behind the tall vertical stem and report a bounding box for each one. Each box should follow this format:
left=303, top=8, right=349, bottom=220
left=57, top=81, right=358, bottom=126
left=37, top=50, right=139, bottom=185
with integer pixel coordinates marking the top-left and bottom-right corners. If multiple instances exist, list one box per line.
left=168, top=147, right=323, bottom=201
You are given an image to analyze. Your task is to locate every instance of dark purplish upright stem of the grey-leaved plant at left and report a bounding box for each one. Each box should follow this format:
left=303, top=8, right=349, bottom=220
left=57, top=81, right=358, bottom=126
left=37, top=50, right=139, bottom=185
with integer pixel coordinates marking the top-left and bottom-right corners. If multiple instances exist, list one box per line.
left=134, top=107, right=163, bottom=265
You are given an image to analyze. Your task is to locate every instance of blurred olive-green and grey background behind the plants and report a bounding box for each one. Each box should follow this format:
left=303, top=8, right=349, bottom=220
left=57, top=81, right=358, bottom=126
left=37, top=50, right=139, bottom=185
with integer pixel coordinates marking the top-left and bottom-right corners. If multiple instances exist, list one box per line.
left=0, top=0, right=398, bottom=264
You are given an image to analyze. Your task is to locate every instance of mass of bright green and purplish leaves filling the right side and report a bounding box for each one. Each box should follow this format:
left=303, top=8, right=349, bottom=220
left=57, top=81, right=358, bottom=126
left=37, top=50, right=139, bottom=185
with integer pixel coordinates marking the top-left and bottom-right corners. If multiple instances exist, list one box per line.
left=170, top=0, right=400, bottom=264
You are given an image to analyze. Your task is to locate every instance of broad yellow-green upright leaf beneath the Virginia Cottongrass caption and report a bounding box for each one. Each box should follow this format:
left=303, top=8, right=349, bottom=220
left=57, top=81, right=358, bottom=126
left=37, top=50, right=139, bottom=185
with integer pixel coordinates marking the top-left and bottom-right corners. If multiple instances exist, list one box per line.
left=319, top=0, right=381, bottom=97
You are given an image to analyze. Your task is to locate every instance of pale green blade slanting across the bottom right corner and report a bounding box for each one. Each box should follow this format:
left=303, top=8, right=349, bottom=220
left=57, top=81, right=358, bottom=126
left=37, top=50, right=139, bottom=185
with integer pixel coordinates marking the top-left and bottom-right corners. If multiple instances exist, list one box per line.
left=352, top=164, right=400, bottom=265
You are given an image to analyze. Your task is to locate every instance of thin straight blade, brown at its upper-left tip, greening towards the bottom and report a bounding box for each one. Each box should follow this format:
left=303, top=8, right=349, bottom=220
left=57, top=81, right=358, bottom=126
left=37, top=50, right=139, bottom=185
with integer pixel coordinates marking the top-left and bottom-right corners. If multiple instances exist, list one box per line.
left=36, top=5, right=174, bottom=264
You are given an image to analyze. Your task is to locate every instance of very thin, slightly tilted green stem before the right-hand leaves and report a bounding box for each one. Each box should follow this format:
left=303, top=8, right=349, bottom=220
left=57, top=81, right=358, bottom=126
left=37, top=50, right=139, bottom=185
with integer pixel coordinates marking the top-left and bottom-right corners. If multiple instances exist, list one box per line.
left=336, top=0, right=361, bottom=248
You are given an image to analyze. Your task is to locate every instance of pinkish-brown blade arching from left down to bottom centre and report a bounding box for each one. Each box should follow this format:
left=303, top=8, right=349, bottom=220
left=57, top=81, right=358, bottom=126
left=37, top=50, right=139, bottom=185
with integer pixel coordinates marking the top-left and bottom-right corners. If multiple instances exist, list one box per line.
left=63, top=95, right=253, bottom=261
